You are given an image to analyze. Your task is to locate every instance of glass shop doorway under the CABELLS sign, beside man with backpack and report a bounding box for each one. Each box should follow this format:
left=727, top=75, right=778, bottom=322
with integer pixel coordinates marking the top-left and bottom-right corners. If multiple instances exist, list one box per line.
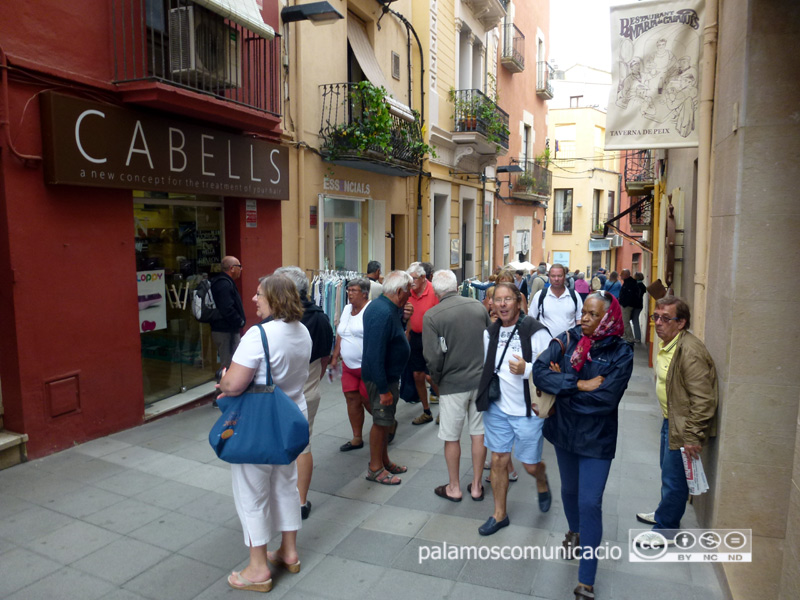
left=133, top=196, right=223, bottom=405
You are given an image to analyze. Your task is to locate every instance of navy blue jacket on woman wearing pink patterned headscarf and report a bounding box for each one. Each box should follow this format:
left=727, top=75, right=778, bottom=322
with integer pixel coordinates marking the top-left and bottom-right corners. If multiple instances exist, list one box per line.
left=533, top=325, right=633, bottom=459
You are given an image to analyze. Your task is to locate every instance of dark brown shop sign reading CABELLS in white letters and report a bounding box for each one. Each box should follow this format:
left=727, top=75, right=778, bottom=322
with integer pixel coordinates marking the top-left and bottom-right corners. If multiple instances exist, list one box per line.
left=42, top=92, right=289, bottom=200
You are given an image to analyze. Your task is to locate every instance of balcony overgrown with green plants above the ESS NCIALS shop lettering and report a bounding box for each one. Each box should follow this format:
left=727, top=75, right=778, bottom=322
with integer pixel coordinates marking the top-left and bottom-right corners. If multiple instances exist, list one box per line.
left=319, top=81, right=430, bottom=177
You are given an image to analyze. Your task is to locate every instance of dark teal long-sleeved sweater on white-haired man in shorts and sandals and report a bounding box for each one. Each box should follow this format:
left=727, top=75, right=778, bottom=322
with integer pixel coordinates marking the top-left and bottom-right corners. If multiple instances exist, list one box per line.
left=361, top=295, right=411, bottom=394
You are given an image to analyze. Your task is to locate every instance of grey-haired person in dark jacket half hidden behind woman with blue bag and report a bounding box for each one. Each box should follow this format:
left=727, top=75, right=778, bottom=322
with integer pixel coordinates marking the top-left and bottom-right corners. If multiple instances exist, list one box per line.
left=275, top=266, right=333, bottom=519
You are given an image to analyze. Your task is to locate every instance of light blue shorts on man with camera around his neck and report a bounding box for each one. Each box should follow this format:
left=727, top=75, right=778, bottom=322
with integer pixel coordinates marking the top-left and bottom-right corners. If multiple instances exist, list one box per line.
left=483, top=403, right=544, bottom=465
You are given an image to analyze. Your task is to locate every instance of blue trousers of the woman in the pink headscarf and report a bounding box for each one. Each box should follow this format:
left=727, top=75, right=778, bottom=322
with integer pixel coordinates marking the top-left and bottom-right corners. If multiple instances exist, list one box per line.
left=556, top=446, right=611, bottom=585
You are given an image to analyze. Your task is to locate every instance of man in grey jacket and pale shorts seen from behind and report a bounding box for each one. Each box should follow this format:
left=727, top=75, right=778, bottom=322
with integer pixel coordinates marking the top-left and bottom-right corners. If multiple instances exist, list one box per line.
left=422, top=271, right=491, bottom=502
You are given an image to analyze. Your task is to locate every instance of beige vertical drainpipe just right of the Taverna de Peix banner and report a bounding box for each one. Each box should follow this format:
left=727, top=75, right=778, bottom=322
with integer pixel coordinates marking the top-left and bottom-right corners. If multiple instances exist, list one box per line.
left=692, top=0, right=718, bottom=340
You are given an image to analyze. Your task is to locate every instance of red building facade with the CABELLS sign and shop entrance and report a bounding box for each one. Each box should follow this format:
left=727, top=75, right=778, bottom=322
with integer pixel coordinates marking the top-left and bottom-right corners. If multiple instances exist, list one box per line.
left=0, top=0, right=289, bottom=457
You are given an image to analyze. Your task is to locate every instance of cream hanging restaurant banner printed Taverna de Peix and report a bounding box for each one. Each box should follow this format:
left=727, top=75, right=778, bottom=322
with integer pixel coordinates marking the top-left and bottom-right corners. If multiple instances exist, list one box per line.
left=605, top=0, right=703, bottom=150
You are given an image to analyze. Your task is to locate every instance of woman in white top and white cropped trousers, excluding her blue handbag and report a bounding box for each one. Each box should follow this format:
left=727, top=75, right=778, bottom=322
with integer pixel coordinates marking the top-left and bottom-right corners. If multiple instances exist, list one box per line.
left=219, top=275, right=311, bottom=592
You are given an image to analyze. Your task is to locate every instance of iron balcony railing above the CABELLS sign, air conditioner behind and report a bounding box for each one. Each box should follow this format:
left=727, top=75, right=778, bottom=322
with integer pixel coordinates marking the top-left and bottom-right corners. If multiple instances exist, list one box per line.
left=111, top=0, right=281, bottom=115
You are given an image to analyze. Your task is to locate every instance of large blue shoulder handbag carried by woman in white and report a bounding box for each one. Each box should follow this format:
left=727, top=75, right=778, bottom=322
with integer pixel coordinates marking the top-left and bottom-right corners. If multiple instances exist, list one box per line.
left=208, top=326, right=308, bottom=465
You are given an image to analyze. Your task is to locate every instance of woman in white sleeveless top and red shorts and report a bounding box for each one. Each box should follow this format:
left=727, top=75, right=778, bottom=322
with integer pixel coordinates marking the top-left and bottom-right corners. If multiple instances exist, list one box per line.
left=330, top=278, right=372, bottom=452
